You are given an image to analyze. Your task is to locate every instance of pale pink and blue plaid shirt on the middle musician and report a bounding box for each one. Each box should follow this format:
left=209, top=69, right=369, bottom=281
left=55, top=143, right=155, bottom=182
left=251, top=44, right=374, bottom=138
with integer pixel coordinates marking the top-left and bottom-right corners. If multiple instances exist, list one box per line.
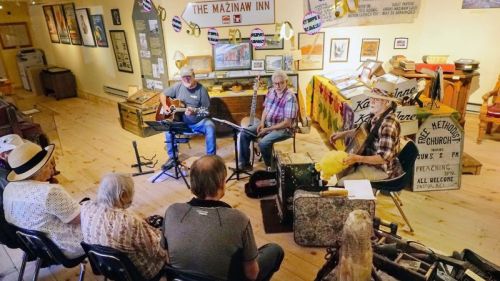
left=264, top=88, right=298, bottom=127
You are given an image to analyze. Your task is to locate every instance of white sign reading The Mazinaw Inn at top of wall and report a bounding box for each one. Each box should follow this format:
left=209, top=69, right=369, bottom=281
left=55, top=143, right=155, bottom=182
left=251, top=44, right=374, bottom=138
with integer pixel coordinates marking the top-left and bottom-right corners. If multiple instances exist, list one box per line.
left=182, top=0, right=274, bottom=28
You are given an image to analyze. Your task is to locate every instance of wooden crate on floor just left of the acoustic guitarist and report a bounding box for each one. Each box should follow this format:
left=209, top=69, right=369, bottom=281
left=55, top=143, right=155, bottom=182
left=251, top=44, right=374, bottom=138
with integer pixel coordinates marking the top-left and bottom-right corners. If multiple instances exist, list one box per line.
left=118, top=102, right=161, bottom=137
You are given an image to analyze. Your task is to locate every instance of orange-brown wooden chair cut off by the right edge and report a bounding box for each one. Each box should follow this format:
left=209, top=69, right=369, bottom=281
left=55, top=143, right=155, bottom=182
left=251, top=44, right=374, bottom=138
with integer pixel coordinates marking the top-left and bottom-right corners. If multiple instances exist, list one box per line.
left=477, top=75, right=500, bottom=143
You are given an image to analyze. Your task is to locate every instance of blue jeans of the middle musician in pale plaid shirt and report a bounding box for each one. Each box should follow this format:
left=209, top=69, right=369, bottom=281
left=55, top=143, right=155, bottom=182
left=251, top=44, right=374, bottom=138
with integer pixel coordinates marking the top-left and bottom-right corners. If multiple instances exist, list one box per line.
left=238, top=124, right=292, bottom=167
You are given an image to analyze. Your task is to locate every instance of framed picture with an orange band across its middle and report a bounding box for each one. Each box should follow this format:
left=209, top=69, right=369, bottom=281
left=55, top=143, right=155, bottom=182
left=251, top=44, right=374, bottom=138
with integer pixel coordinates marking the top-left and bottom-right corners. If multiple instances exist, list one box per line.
left=299, top=32, right=325, bottom=70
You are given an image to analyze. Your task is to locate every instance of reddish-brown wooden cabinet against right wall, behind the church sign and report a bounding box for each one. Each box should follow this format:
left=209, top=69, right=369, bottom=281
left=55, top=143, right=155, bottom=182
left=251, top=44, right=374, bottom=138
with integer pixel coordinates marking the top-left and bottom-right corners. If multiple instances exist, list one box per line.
left=392, top=69, right=479, bottom=127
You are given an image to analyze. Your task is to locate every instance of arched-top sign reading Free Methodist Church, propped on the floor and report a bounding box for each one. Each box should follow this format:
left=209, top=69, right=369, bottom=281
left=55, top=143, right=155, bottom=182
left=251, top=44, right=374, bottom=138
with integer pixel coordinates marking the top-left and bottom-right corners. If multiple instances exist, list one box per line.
left=413, top=116, right=464, bottom=191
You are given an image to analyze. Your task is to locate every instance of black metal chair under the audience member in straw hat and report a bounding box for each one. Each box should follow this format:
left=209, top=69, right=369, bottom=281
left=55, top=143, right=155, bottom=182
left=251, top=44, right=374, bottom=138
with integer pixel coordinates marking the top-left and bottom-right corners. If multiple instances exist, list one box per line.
left=16, top=227, right=87, bottom=281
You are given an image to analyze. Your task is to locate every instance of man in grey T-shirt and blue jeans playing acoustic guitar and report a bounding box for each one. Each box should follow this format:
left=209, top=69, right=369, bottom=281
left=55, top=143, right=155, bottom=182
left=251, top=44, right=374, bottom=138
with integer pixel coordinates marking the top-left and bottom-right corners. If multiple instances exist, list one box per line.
left=160, top=66, right=216, bottom=170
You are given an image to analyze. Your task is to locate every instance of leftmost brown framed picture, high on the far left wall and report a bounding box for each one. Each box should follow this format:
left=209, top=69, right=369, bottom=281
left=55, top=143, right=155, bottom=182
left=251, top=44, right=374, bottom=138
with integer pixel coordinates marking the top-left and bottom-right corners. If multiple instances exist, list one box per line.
left=0, top=22, right=32, bottom=49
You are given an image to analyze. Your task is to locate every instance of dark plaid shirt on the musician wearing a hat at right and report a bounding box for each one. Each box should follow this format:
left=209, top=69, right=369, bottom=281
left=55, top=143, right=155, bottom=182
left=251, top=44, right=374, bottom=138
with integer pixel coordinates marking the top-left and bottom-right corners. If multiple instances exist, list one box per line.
left=365, top=113, right=403, bottom=178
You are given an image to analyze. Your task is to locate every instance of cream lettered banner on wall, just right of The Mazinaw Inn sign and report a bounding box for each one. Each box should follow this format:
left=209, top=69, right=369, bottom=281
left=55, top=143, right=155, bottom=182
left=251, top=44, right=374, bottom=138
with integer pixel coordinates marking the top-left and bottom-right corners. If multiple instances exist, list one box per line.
left=303, top=0, right=421, bottom=27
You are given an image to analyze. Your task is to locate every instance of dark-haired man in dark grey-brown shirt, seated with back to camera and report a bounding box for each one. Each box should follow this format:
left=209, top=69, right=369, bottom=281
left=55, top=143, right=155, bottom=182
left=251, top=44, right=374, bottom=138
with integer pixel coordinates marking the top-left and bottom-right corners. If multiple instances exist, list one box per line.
left=162, top=155, right=284, bottom=280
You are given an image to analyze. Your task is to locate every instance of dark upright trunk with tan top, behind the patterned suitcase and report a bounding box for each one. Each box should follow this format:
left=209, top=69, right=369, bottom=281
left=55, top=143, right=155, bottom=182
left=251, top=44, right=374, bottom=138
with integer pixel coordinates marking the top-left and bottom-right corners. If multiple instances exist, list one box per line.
left=275, top=151, right=321, bottom=223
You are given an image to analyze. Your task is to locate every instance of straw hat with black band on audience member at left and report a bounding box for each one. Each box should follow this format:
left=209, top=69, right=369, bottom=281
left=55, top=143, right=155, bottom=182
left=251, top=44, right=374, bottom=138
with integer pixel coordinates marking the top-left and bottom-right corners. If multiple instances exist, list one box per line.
left=7, top=142, right=54, bottom=181
